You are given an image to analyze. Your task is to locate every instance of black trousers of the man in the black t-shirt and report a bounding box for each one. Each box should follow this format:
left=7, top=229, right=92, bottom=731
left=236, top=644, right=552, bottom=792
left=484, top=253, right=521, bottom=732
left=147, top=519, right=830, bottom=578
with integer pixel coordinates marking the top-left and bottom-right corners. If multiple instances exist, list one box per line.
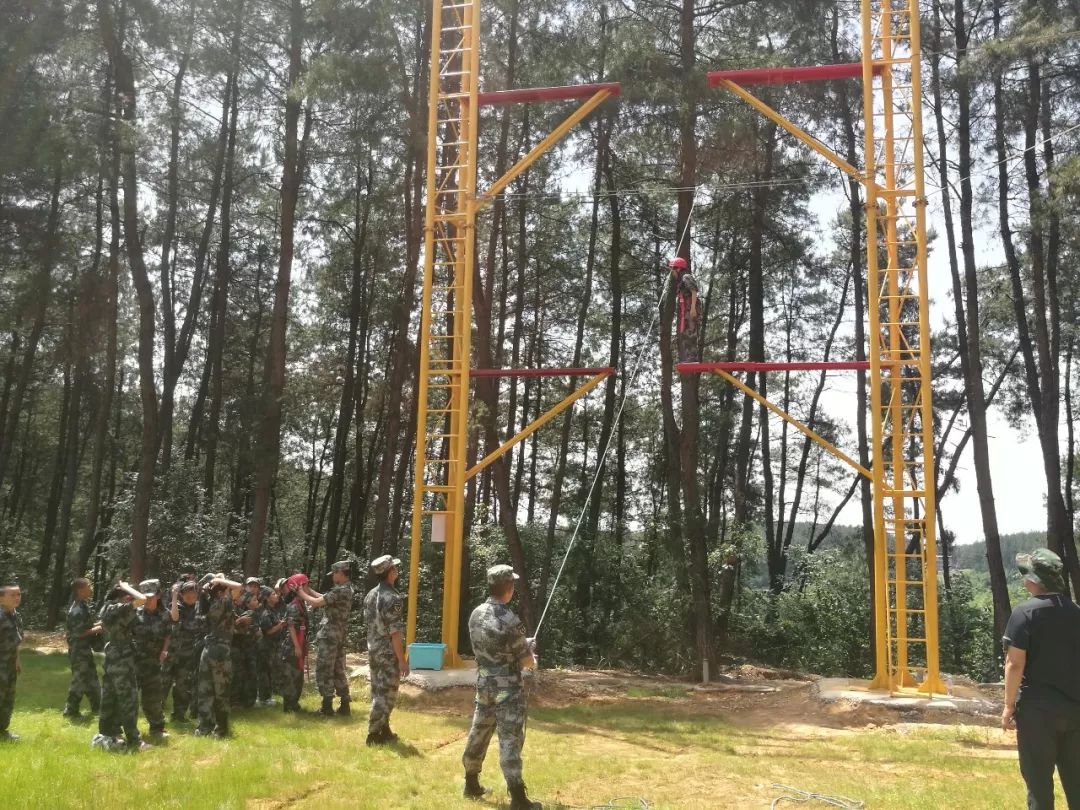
left=1016, top=700, right=1080, bottom=810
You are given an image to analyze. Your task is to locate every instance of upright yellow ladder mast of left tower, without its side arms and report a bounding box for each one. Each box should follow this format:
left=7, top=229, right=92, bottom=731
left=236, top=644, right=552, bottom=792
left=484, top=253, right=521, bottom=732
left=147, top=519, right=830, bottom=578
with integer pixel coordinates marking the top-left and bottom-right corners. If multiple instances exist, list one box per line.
left=406, top=0, right=480, bottom=666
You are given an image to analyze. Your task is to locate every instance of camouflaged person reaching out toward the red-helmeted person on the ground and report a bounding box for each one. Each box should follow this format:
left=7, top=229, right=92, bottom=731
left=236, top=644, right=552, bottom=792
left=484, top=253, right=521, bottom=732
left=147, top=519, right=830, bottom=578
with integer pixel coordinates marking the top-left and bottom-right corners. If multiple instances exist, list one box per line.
left=297, top=559, right=355, bottom=717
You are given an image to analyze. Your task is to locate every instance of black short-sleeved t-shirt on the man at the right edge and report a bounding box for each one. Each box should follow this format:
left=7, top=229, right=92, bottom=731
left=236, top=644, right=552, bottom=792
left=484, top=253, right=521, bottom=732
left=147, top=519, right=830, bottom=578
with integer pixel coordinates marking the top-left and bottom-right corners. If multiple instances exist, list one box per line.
left=1003, top=594, right=1080, bottom=704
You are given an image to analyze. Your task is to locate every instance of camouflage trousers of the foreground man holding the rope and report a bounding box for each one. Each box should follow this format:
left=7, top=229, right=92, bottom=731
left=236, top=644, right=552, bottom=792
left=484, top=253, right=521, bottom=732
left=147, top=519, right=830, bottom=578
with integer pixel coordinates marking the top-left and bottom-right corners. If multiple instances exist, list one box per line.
left=461, top=677, right=525, bottom=785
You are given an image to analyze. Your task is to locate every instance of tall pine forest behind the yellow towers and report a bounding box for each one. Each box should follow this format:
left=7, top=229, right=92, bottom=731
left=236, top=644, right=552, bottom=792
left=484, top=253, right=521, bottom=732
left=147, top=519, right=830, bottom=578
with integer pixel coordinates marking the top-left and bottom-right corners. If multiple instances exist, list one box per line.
left=0, top=0, right=1080, bottom=679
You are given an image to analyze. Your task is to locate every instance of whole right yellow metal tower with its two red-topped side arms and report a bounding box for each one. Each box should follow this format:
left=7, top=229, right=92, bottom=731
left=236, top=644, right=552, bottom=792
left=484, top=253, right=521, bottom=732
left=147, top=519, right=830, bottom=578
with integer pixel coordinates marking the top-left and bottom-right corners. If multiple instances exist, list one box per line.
left=704, top=0, right=945, bottom=694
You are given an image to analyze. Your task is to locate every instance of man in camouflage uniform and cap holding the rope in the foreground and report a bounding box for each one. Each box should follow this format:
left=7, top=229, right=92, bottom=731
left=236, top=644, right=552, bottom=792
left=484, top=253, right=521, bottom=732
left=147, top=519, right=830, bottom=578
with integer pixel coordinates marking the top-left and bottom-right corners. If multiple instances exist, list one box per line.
left=461, top=565, right=542, bottom=810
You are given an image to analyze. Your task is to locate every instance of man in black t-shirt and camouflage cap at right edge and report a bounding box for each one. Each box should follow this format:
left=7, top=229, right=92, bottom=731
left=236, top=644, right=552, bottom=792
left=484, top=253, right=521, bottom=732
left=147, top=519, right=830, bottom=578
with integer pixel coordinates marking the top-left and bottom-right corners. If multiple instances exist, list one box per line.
left=1001, top=549, right=1080, bottom=810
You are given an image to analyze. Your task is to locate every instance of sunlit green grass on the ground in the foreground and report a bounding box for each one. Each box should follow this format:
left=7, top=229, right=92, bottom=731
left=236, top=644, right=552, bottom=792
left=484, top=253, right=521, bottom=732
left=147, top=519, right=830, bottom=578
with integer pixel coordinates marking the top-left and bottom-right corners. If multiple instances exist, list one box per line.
left=0, top=651, right=1045, bottom=810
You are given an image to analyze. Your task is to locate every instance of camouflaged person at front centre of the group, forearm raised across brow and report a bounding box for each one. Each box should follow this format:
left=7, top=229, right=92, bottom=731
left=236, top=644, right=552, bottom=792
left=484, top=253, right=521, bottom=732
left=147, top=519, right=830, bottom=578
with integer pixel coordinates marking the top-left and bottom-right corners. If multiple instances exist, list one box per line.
left=195, top=576, right=241, bottom=737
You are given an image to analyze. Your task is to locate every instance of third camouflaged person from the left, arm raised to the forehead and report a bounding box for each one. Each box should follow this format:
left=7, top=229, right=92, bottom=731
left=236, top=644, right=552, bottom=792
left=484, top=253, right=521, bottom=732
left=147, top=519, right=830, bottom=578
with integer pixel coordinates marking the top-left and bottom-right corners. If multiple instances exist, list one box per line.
left=91, top=582, right=148, bottom=751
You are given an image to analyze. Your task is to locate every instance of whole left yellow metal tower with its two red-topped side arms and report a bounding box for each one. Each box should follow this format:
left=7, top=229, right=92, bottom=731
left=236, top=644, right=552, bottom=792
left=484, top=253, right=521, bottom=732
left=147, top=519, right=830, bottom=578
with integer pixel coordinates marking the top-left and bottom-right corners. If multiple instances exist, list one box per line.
left=406, top=0, right=619, bottom=666
